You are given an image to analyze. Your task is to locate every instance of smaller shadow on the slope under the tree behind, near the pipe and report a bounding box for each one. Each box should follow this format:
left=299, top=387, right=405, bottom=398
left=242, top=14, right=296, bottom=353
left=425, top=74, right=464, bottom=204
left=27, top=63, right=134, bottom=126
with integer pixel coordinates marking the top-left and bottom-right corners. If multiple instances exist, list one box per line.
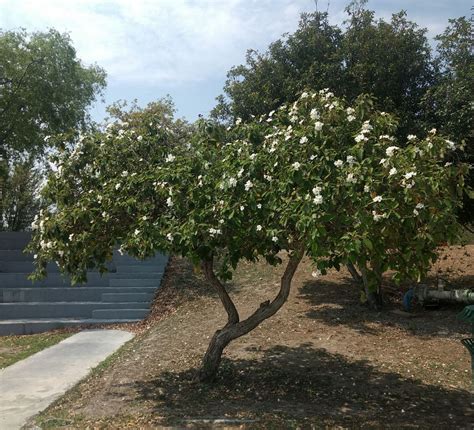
left=298, top=278, right=469, bottom=337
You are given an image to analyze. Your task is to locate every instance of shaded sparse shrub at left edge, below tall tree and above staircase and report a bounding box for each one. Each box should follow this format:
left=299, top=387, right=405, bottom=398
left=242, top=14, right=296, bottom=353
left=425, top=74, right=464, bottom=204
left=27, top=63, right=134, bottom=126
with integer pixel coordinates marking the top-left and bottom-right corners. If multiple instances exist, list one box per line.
left=0, top=159, right=41, bottom=231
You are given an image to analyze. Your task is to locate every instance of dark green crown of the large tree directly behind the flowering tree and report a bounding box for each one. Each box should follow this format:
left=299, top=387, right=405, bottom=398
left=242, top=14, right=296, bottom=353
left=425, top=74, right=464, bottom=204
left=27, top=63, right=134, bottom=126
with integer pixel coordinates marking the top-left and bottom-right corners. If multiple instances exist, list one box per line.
left=213, top=2, right=432, bottom=136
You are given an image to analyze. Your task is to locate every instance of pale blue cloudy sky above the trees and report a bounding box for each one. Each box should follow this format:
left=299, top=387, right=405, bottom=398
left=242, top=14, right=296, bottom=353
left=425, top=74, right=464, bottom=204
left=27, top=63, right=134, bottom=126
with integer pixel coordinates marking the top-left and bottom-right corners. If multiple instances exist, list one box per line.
left=0, top=0, right=471, bottom=121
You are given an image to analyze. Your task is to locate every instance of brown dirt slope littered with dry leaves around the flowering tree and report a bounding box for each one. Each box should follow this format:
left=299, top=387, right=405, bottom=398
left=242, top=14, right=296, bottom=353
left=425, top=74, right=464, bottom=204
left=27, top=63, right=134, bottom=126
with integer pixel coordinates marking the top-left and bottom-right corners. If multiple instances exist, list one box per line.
left=36, top=245, right=474, bottom=429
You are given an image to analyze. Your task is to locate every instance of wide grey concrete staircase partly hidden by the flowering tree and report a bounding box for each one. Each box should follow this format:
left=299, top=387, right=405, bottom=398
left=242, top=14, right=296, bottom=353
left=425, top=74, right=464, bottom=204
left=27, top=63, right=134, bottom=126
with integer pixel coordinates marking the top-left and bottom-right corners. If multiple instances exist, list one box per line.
left=0, top=232, right=168, bottom=335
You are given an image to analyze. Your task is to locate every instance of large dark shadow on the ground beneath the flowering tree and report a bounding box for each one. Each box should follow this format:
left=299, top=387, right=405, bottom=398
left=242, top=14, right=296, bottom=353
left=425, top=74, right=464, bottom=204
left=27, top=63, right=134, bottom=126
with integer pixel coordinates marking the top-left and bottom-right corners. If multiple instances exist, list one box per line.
left=135, top=344, right=472, bottom=428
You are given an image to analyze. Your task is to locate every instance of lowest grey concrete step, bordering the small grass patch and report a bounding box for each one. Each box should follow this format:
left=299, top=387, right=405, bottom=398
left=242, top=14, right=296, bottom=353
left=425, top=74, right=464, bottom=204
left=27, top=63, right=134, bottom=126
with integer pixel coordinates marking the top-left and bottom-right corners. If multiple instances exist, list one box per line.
left=0, top=318, right=141, bottom=336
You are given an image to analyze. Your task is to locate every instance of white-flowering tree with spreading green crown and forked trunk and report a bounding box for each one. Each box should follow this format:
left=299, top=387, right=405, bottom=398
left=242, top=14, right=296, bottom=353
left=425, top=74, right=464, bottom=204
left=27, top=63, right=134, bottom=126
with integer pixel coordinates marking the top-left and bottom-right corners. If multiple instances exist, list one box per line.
left=32, top=90, right=465, bottom=381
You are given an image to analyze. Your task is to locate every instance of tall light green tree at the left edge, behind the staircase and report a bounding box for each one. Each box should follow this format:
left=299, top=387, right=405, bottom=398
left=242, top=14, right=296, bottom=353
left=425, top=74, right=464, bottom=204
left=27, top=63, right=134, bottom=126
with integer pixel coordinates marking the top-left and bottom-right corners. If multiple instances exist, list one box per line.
left=0, top=30, right=105, bottom=229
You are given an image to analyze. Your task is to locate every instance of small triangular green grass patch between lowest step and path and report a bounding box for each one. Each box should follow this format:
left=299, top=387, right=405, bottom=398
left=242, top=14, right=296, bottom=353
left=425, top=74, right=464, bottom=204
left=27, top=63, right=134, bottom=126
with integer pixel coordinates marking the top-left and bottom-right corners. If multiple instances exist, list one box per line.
left=0, top=333, right=72, bottom=369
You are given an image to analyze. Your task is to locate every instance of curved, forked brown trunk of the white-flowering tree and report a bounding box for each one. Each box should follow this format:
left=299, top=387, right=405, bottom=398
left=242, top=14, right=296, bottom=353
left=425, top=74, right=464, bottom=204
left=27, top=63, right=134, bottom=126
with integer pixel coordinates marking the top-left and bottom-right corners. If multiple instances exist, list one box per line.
left=198, top=250, right=303, bottom=382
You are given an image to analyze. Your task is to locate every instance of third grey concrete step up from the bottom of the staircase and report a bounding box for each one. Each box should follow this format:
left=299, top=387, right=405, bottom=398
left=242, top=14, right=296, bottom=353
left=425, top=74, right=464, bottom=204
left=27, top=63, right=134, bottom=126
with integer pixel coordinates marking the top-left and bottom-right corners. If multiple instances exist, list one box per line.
left=0, top=287, right=156, bottom=303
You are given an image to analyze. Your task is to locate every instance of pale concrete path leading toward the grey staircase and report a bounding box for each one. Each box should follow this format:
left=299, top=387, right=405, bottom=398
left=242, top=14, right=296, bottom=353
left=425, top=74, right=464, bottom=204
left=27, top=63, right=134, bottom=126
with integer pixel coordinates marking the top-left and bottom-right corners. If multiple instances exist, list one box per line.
left=0, top=330, right=133, bottom=430
